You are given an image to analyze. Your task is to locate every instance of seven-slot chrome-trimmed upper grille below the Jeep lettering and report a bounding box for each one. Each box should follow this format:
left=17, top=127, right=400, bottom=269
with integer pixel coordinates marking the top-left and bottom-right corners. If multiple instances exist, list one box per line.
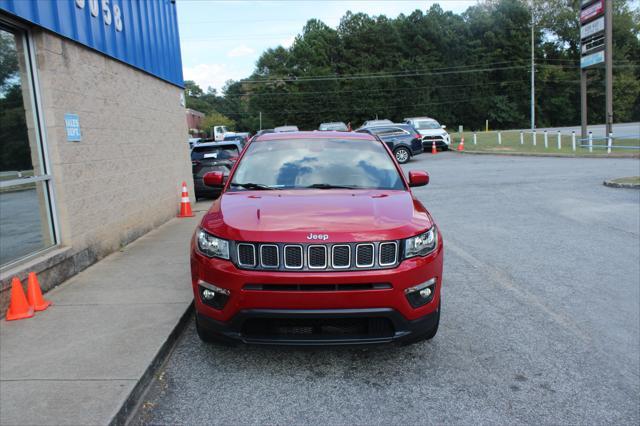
left=231, top=241, right=400, bottom=271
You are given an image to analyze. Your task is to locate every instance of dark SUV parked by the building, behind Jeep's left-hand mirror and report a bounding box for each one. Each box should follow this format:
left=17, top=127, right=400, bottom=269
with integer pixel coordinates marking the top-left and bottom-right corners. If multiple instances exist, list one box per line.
left=191, top=141, right=242, bottom=200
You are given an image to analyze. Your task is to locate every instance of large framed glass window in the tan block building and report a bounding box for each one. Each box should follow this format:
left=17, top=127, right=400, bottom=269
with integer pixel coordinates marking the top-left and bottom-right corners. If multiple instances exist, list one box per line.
left=0, top=21, right=57, bottom=267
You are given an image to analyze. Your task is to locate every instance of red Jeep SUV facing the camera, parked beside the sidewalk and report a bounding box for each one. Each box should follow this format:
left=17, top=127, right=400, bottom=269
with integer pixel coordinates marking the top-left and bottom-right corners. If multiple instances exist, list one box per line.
left=191, top=132, right=443, bottom=345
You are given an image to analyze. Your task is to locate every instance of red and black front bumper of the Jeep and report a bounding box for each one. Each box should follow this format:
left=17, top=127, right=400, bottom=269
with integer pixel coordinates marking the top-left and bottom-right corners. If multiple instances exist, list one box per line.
left=191, top=240, right=443, bottom=344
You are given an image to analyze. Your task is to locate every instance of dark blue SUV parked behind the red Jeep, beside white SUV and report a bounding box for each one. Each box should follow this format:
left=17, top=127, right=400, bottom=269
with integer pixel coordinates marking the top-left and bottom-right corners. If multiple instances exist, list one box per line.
left=357, top=123, right=423, bottom=164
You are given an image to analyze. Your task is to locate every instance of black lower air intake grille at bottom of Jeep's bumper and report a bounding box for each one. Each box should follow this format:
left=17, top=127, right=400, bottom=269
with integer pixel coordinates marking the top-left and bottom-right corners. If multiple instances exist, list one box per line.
left=242, top=317, right=395, bottom=340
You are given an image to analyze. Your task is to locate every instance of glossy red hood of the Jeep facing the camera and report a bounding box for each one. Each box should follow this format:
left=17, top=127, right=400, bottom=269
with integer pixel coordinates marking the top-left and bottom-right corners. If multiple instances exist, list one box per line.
left=202, top=189, right=432, bottom=243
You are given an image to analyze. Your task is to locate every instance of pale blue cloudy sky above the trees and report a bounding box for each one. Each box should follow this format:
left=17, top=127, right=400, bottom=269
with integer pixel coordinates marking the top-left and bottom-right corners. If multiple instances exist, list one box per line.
left=176, top=0, right=476, bottom=93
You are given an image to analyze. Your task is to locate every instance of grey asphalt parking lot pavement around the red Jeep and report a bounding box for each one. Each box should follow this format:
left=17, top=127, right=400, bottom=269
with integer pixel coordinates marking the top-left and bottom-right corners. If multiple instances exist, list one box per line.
left=135, top=153, right=640, bottom=425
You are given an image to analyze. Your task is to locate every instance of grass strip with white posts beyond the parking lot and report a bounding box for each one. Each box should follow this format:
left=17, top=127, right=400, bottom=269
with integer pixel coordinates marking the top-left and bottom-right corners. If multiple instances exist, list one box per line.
left=451, top=130, right=640, bottom=157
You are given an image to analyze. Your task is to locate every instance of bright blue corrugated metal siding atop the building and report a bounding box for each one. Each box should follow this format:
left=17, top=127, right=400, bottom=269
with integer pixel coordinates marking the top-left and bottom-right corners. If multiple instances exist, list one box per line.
left=0, top=0, right=183, bottom=86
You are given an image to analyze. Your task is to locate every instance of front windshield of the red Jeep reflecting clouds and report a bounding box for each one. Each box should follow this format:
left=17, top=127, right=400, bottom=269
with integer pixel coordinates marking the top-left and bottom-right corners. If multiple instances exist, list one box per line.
left=230, top=139, right=404, bottom=190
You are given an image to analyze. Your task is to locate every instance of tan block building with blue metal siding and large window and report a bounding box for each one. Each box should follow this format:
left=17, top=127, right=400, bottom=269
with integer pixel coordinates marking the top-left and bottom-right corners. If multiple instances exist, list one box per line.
left=0, top=0, right=192, bottom=306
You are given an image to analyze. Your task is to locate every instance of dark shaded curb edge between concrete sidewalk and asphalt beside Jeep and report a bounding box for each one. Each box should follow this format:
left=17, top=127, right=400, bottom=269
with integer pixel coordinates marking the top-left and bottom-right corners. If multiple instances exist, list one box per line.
left=109, top=302, right=194, bottom=426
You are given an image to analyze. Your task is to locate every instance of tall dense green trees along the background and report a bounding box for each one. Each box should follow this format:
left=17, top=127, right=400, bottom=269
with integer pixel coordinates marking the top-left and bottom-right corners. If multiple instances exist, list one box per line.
left=185, top=0, right=640, bottom=131
